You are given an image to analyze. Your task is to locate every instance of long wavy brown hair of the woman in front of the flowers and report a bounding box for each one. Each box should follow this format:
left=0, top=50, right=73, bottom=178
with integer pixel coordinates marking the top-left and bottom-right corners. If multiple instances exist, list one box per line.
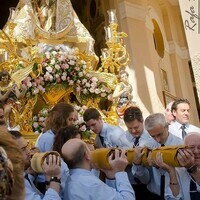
left=44, top=102, right=74, bottom=134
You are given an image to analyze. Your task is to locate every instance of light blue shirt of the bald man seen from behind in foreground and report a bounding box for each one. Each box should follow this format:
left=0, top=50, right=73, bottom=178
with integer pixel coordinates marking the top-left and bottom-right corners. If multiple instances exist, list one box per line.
left=64, top=168, right=135, bottom=200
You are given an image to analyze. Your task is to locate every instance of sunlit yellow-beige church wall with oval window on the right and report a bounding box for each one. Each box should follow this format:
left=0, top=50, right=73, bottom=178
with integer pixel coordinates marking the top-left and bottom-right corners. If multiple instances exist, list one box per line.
left=110, top=0, right=199, bottom=125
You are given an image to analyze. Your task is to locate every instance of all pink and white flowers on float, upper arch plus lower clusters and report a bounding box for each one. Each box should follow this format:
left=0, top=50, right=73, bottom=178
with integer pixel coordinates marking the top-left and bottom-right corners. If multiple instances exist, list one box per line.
left=22, top=47, right=112, bottom=138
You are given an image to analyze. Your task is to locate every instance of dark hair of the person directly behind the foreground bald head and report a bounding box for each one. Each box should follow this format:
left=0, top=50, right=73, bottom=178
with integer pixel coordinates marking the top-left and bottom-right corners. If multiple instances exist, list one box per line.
left=53, top=126, right=82, bottom=155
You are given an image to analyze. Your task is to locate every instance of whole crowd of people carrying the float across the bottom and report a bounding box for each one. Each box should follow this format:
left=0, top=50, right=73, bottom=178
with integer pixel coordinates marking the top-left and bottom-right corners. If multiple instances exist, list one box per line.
left=0, top=99, right=200, bottom=200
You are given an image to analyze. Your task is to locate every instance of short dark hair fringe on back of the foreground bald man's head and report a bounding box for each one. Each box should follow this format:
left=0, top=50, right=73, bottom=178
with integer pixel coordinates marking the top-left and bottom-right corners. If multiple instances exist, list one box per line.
left=64, top=143, right=86, bottom=169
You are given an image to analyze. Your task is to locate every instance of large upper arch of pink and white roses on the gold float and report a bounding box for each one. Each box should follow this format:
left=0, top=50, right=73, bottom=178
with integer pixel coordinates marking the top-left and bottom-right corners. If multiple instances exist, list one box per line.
left=23, top=48, right=111, bottom=99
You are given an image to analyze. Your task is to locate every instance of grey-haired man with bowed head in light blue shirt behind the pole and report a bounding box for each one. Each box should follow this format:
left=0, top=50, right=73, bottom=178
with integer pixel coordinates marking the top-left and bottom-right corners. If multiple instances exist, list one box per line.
left=145, top=113, right=182, bottom=200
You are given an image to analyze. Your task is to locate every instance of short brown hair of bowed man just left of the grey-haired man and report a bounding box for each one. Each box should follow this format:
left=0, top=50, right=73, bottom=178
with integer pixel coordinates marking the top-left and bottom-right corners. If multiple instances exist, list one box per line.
left=124, top=106, right=144, bottom=122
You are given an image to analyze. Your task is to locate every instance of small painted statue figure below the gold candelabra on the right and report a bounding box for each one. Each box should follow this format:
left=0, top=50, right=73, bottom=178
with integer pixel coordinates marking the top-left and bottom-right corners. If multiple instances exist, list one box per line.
left=112, top=70, right=133, bottom=117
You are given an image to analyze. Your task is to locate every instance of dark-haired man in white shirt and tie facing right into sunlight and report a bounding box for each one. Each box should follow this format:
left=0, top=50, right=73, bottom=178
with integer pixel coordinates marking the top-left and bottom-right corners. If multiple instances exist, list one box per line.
left=169, top=99, right=200, bottom=139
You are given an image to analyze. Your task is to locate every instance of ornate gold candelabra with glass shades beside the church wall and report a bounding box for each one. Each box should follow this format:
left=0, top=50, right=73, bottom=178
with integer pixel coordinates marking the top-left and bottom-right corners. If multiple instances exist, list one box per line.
left=99, top=9, right=130, bottom=74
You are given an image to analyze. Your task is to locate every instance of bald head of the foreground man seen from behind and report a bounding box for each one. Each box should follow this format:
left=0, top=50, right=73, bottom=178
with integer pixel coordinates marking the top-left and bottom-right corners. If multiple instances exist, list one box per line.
left=62, top=138, right=87, bottom=169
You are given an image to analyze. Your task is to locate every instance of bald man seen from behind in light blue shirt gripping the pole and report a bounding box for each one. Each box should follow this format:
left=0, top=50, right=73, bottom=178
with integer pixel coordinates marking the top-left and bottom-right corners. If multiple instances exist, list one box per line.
left=62, top=138, right=135, bottom=200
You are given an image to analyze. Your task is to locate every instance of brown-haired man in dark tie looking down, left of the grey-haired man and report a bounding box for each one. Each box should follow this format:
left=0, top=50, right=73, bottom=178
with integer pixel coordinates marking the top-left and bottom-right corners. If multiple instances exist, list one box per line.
left=124, top=106, right=150, bottom=200
